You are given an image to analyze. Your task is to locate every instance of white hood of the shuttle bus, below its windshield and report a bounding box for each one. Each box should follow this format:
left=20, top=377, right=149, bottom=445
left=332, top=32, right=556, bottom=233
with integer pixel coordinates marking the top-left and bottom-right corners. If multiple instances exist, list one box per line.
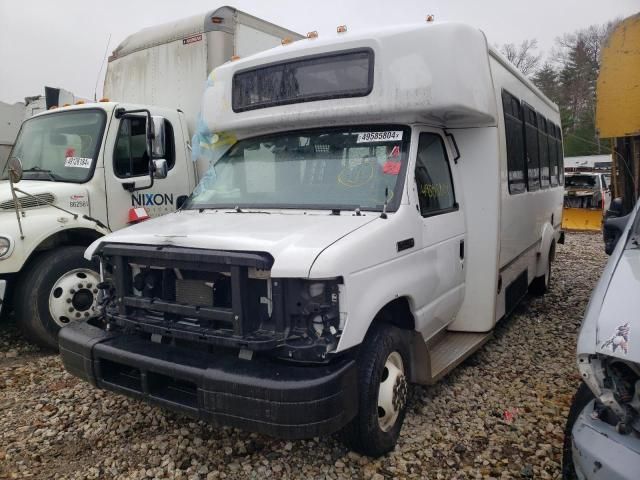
left=85, top=210, right=379, bottom=278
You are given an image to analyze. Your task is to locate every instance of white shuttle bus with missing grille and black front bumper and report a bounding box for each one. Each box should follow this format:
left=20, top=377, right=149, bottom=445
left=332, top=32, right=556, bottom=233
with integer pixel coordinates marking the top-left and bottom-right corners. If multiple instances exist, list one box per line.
left=59, top=23, right=563, bottom=456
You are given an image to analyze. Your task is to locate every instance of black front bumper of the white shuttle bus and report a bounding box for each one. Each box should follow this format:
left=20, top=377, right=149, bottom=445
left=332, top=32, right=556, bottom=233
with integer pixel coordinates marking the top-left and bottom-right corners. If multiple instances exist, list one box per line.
left=59, top=322, right=358, bottom=439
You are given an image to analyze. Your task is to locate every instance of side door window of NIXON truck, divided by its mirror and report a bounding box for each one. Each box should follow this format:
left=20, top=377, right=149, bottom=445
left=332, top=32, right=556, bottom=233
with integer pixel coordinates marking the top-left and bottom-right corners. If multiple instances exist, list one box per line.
left=113, top=116, right=175, bottom=178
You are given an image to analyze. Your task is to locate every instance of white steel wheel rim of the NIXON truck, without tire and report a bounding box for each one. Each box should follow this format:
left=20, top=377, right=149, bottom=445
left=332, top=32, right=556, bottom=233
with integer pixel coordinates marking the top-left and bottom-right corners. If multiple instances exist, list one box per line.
left=49, top=268, right=100, bottom=327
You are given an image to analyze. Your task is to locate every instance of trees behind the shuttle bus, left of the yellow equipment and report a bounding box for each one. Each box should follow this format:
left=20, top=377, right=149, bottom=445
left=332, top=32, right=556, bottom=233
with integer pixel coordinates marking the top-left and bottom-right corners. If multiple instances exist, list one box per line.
left=499, top=19, right=620, bottom=157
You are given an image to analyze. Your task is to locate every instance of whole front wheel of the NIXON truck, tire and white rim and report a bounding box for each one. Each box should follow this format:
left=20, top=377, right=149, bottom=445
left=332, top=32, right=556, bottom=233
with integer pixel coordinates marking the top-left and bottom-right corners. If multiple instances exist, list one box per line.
left=14, top=246, right=100, bottom=350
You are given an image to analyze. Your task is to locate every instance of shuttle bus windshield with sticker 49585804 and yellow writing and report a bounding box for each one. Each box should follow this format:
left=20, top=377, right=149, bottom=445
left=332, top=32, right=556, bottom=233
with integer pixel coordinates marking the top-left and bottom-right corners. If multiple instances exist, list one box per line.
left=185, top=125, right=410, bottom=211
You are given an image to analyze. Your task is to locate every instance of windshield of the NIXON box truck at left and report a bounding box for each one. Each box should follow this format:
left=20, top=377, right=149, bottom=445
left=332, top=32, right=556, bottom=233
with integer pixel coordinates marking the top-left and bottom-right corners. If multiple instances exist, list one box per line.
left=2, top=109, right=106, bottom=183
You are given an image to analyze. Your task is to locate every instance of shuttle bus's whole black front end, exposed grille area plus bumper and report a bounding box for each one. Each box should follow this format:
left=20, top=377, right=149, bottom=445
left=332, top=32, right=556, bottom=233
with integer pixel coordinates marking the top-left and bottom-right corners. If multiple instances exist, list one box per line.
left=59, top=243, right=358, bottom=439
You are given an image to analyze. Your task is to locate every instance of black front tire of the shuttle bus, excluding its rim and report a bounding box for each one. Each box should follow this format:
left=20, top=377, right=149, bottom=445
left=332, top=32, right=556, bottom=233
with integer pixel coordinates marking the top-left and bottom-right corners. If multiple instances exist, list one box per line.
left=340, top=324, right=410, bottom=457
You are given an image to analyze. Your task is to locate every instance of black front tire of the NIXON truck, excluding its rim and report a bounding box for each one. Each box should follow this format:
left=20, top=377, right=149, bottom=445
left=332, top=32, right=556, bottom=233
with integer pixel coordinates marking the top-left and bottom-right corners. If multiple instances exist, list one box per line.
left=13, top=246, right=98, bottom=350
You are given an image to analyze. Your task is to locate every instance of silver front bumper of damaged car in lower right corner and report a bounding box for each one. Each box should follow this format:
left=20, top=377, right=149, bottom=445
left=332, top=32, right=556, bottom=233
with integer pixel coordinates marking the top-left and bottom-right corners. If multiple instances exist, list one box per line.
left=571, top=401, right=640, bottom=480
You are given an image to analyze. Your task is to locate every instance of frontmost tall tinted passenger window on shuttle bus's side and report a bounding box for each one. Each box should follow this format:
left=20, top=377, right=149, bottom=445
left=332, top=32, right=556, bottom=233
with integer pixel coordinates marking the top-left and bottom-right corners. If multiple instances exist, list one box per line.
left=502, top=90, right=526, bottom=194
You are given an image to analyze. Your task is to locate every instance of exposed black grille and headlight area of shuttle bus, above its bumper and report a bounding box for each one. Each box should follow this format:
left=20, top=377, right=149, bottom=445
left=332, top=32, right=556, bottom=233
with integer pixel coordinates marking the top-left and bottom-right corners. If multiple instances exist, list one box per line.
left=94, top=244, right=341, bottom=362
